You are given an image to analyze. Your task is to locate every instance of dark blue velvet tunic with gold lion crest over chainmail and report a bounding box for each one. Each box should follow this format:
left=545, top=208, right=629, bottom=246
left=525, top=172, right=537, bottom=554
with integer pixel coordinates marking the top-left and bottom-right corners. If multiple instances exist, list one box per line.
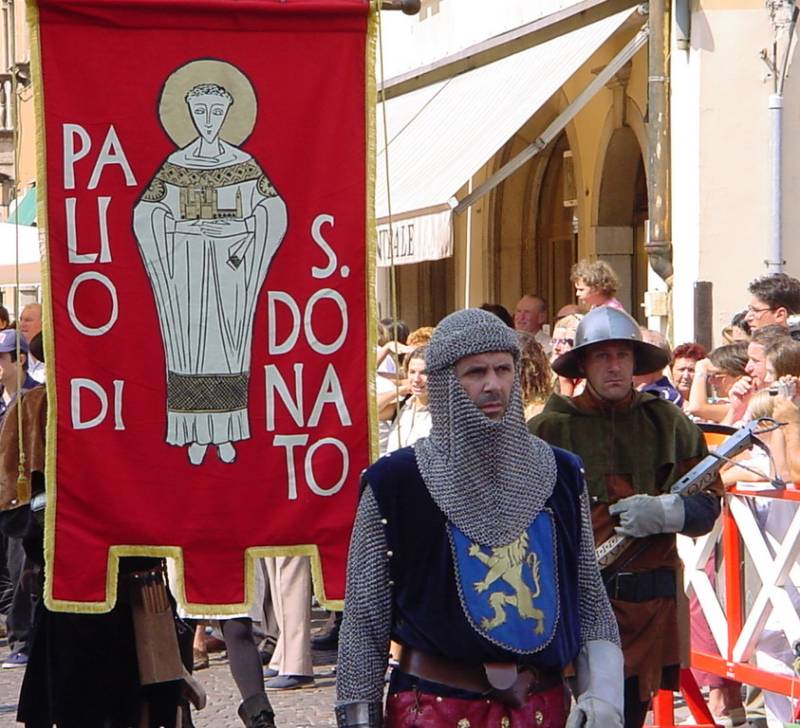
left=367, top=448, right=584, bottom=668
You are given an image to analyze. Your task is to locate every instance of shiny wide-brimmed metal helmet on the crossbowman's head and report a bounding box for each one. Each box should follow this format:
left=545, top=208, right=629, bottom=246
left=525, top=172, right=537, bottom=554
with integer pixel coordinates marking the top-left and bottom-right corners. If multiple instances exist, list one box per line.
left=553, top=306, right=669, bottom=379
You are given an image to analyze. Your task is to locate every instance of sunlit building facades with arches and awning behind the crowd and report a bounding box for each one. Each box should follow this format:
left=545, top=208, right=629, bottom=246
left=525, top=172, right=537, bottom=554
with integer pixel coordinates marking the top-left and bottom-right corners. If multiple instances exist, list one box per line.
left=0, top=0, right=800, bottom=336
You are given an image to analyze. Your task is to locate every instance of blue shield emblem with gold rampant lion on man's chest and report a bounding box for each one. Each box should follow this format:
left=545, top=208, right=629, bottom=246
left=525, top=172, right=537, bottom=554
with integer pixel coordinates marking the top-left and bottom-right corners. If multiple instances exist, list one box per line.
left=448, top=510, right=559, bottom=653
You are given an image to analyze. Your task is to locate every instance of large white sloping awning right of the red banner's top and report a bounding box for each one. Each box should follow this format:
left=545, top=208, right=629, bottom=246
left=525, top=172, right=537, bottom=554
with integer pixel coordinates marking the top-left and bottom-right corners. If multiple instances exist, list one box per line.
left=375, top=9, right=634, bottom=265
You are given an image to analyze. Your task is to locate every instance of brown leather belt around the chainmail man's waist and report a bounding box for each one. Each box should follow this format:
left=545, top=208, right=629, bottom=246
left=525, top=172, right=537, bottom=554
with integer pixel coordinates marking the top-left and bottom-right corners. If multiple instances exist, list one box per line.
left=400, top=646, right=562, bottom=694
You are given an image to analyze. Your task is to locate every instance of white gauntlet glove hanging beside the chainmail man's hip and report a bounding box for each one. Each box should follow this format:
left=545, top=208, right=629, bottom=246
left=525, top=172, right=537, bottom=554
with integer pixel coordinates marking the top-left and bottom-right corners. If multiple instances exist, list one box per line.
left=566, top=640, right=625, bottom=728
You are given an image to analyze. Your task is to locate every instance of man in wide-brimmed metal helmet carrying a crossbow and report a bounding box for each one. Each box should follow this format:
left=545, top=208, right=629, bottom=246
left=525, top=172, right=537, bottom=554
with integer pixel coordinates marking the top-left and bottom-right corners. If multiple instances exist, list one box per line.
left=529, top=307, right=722, bottom=728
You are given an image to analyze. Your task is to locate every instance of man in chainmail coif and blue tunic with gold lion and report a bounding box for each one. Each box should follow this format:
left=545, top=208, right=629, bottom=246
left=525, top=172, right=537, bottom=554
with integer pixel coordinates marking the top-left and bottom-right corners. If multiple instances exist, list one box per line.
left=336, top=309, right=623, bottom=728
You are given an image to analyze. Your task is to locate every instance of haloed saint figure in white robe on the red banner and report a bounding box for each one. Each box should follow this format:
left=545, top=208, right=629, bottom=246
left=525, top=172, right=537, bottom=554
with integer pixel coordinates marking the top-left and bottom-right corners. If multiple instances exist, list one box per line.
left=133, top=59, right=287, bottom=465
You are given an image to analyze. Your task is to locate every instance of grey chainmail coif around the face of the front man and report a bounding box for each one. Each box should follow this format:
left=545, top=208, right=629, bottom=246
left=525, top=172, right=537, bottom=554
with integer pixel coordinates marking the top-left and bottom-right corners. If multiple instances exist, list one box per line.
left=414, top=308, right=556, bottom=546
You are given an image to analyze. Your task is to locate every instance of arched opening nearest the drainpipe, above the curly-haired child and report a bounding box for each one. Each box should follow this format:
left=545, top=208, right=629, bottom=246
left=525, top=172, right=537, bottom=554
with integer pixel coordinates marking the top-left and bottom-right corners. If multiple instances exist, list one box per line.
left=595, top=126, right=647, bottom=322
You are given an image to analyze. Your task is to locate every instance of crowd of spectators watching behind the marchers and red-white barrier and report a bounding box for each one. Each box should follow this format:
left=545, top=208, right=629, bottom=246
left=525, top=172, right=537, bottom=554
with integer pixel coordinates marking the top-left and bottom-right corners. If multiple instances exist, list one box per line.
left=7, top=261, right=800, bottom=728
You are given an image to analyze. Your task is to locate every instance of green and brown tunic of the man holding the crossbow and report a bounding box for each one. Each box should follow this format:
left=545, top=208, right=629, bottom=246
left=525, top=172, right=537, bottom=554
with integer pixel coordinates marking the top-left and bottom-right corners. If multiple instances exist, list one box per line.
left=528, top=390, right=707, bottom=701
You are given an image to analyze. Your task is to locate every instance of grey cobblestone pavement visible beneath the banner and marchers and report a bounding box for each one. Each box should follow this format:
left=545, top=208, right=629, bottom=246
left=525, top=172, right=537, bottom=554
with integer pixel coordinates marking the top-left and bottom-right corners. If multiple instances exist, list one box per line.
left=0, top=624, right=708, bottom=728
